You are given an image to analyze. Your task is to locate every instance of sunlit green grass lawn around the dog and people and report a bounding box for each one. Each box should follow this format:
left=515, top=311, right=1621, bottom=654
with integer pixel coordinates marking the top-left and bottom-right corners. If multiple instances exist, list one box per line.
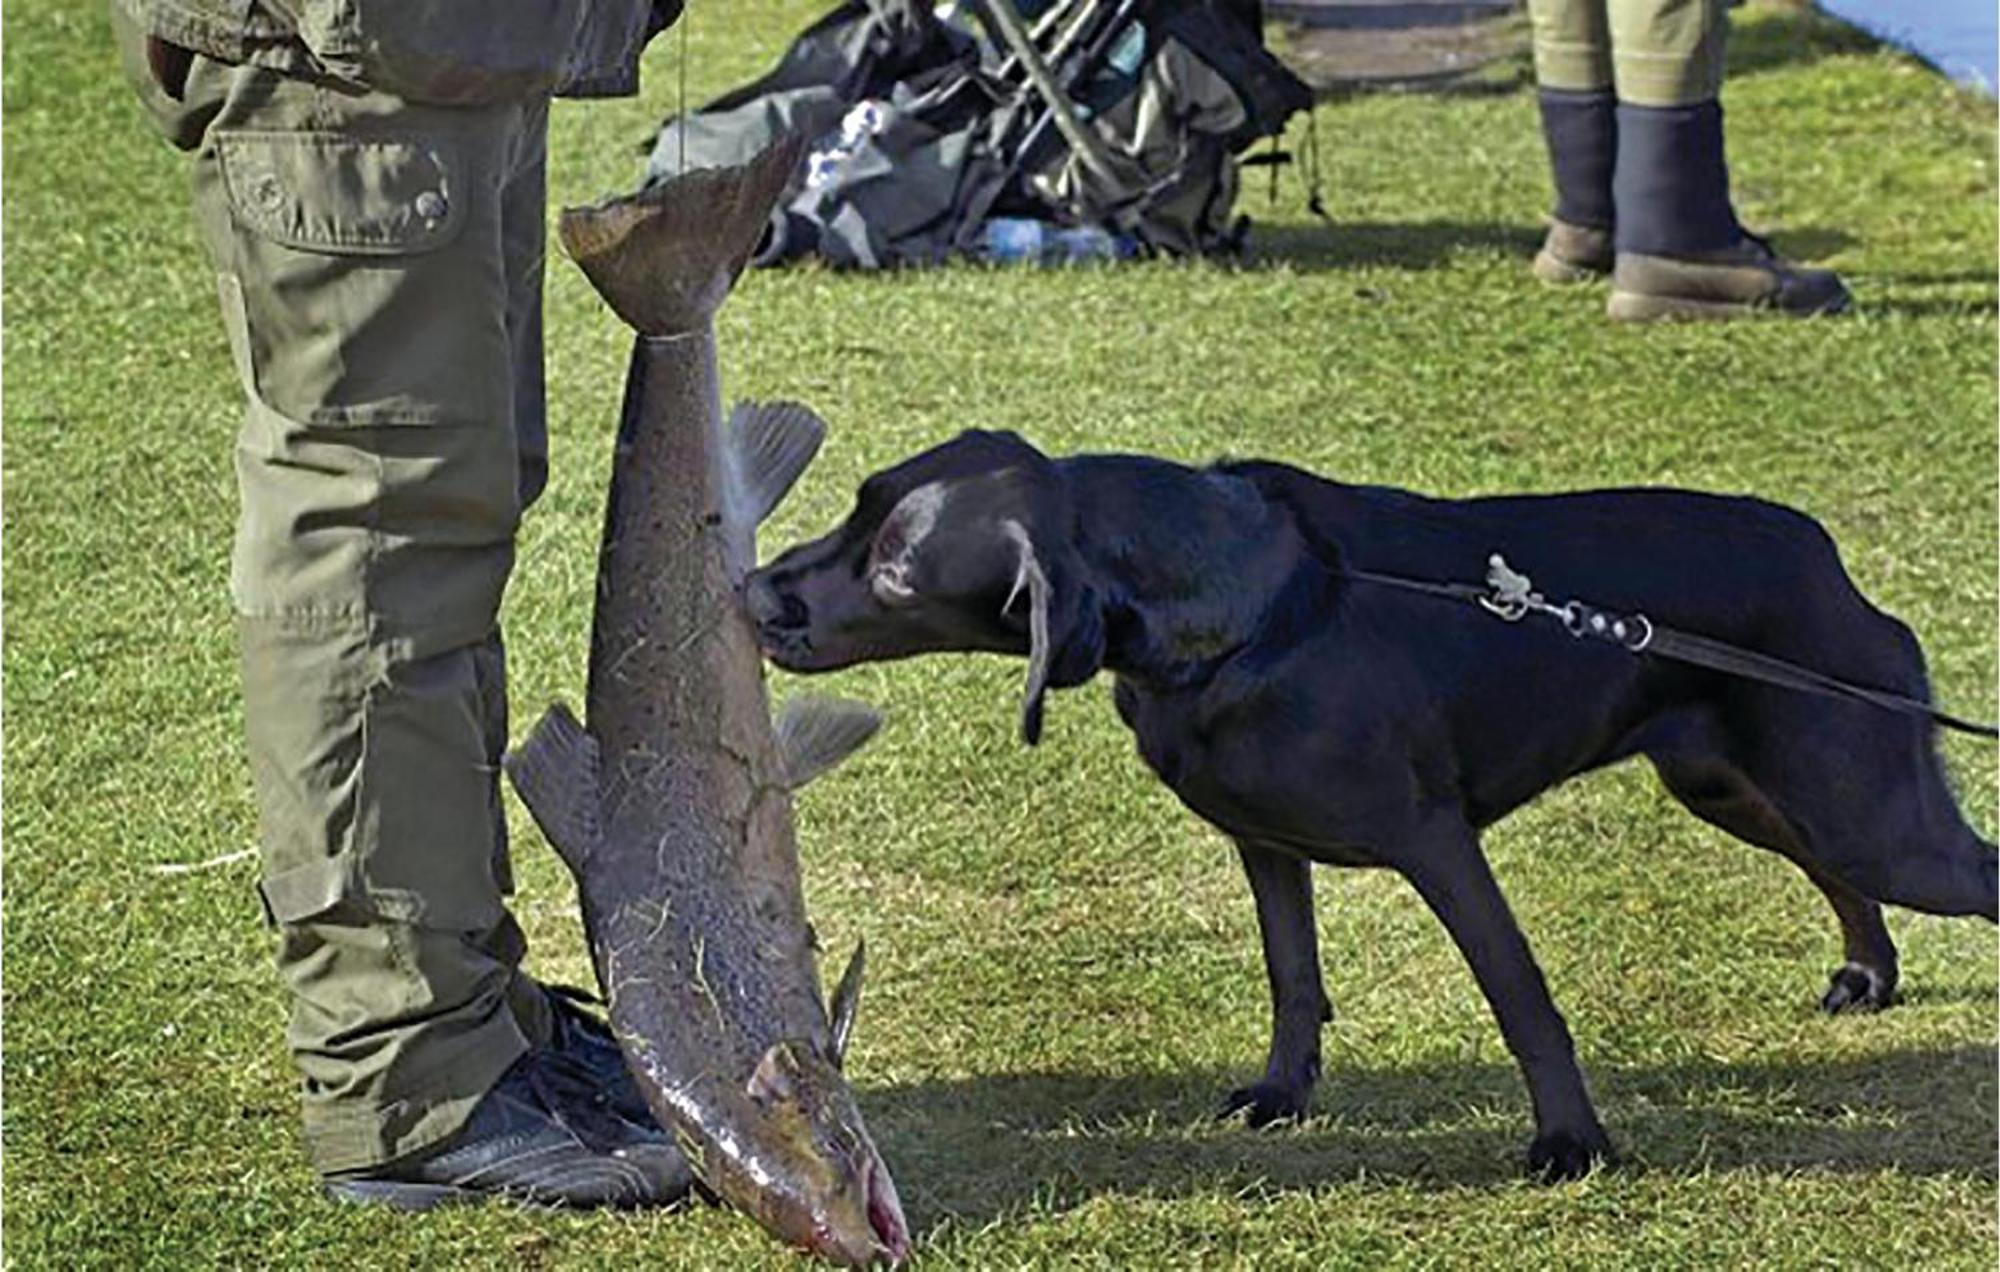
left=4, top=0, right=2000, bottom=1268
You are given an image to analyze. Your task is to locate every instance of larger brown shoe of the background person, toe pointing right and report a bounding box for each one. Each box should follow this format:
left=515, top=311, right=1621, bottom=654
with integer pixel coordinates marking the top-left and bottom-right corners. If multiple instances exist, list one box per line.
left=1604, top=232, right=1852, bottom=322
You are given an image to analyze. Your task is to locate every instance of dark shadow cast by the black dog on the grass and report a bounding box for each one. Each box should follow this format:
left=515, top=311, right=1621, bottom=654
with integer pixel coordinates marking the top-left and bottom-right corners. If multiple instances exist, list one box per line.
left=864, top=1046, right=1996, bottom=1232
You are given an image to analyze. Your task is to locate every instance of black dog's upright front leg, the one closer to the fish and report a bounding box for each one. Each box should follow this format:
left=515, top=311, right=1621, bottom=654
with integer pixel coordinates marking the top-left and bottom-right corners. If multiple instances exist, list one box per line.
left=1222, top=840, right=1332, bottom=1126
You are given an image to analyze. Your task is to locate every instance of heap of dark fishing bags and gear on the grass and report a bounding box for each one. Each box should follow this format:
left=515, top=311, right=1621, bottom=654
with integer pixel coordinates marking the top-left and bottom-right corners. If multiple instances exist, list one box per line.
left=646, top=0, right=1312, bottom=270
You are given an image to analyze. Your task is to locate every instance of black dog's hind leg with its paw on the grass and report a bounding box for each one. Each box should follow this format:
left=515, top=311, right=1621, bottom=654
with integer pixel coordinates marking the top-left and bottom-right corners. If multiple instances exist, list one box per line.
left=1652, top=754, right=1898, bottom=1012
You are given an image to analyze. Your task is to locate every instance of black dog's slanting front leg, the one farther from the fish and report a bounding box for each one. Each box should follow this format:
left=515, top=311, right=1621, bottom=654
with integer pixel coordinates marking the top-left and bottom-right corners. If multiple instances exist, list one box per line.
left=1380, top=814, right=1616, bottom=1180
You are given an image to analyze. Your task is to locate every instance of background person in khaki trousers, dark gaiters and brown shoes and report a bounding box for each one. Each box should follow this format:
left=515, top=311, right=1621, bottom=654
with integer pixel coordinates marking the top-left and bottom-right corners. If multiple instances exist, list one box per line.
left=1528, top=0, right=1848, bottom=320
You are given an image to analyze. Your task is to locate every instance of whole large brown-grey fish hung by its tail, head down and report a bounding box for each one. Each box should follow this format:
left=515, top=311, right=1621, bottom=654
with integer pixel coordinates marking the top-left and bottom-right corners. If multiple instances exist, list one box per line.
left=506, top=142, right=910, bottom=1266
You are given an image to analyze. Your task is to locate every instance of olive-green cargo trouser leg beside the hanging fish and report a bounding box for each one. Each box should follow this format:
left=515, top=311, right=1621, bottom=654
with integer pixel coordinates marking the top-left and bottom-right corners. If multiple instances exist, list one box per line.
left=188, top=60, right=546, bottom=1170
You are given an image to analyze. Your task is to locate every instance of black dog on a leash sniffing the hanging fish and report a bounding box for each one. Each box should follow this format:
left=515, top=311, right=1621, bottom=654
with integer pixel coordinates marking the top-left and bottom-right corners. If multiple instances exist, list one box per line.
left=746, top=432, right=1996, bottom=1178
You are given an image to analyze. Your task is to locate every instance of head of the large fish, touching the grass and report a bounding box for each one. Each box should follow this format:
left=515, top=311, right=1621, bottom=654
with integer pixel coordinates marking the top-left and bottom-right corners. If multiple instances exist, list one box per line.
left=710, top=1042, right=910, bottom=1268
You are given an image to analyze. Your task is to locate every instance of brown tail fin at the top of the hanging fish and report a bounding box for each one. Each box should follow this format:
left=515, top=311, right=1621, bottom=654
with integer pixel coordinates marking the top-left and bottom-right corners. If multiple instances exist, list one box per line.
left=556, top=134, right=804, bottom=336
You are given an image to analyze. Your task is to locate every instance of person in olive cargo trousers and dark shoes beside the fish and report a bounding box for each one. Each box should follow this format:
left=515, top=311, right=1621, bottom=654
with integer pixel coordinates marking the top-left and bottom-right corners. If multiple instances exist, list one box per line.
left=112, top=0, right=690, bottom=1208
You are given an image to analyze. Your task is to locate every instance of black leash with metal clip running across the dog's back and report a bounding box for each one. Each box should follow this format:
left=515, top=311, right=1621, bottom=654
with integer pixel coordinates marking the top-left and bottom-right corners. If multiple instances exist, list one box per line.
left=1340, top=552, right=2000, bottom=738
